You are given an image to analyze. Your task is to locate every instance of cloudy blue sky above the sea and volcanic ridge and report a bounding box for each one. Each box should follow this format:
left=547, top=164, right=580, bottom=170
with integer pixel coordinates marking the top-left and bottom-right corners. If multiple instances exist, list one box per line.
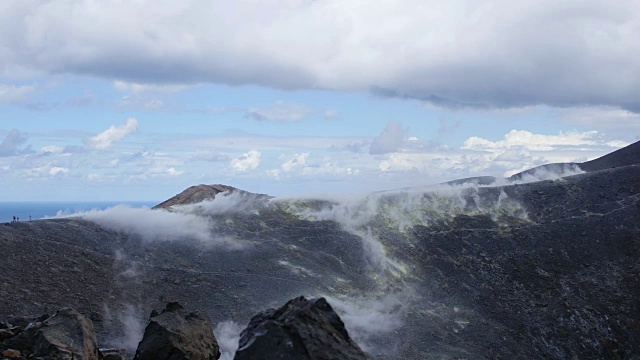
left=0, top=0, right=640, bottom=201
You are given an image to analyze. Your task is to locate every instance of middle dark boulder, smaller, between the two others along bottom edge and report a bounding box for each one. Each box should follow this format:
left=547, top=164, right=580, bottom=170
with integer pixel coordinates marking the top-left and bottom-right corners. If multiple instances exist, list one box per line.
left=134, top=302, right=220, bottom=360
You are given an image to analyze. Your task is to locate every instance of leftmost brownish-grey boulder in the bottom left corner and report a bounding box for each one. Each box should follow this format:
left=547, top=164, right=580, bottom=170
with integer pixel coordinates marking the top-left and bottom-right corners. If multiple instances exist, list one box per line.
left=4, top=308, right=99, bottom=360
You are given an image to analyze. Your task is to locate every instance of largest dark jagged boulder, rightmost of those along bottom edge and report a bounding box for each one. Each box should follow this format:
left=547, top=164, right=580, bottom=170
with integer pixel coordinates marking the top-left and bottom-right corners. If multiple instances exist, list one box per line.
left=234, top=296, right=366, bottom=360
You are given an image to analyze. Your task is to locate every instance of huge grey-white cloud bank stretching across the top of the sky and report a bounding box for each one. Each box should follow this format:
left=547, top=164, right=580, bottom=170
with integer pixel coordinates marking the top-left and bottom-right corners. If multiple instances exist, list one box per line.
left=0, top=0, right=640, bottom=112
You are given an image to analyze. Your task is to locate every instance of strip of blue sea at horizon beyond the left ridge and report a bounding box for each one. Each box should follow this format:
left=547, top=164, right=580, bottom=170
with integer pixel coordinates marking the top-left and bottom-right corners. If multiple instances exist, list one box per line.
left=0, top=201, right=160, bottom=223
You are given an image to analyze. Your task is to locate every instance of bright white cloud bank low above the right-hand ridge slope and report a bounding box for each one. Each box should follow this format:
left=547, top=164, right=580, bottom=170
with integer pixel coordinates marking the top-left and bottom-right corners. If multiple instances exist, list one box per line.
left=378, top=130, right=628, bottom=181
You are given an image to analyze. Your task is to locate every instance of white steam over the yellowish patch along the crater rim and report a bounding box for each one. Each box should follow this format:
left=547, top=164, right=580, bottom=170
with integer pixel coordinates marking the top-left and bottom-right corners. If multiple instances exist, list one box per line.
left=280, top=182, right=526, bottom=278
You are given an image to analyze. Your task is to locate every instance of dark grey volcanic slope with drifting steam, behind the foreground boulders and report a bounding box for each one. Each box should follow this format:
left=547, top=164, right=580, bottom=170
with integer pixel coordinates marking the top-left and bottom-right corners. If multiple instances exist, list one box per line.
left=0, top=143, right=640, bottom=359
